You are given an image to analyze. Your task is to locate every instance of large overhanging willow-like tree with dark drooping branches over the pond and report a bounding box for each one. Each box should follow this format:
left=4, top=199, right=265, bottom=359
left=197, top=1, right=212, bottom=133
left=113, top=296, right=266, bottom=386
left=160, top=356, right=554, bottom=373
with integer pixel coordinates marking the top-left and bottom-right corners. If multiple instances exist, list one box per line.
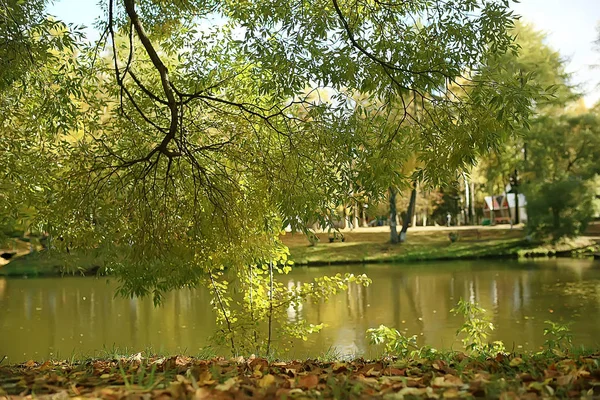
left=2, top=0, right=530, bottom=351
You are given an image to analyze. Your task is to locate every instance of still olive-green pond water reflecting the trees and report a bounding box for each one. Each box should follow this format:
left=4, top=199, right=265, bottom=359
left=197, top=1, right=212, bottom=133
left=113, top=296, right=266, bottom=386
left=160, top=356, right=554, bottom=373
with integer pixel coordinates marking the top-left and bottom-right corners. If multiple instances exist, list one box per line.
left=0, top=259, right=600, bottom=363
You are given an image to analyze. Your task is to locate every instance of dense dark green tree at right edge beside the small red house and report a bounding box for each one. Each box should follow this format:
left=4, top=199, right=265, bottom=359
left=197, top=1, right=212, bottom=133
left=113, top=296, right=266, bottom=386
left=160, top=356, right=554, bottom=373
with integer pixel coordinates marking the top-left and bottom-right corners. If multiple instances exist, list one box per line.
left=523, top=114, right=600, bottom=241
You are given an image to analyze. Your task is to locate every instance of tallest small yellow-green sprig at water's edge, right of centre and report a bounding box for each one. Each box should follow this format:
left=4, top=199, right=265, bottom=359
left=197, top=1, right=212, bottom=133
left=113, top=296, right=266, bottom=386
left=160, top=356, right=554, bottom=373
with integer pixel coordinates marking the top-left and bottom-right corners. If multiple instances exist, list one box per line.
left=450, top=299, right=505, bottom=354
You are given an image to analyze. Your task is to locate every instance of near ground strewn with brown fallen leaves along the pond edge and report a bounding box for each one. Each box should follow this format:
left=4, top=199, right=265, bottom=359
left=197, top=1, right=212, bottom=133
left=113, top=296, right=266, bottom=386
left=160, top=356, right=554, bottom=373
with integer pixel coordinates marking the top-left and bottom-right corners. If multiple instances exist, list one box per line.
left=0, top=353, right=600, bottom=399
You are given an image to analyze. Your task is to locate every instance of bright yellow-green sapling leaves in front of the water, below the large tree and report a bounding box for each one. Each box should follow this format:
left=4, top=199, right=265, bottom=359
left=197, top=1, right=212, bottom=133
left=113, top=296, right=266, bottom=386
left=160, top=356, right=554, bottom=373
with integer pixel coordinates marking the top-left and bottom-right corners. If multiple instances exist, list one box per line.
left=206, top=248, right=371, bottom=356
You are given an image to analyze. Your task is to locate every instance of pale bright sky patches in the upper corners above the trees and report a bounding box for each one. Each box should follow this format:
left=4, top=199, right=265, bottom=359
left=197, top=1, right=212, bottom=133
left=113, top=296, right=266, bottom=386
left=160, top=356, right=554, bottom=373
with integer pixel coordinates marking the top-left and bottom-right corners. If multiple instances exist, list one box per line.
left=50, top=0, right=600, bottom=106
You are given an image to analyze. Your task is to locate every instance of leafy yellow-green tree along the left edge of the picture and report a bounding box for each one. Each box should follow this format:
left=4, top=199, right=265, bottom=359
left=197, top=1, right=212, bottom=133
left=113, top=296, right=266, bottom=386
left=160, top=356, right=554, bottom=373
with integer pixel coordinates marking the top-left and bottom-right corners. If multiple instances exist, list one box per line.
left=0, top=0, right=82, bottom=243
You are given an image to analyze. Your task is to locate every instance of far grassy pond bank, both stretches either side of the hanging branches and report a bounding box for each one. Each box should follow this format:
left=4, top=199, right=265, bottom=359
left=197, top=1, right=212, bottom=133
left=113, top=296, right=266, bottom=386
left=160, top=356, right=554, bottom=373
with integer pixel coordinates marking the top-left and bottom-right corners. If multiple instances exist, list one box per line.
left=0, top=227, right=600, bottom=277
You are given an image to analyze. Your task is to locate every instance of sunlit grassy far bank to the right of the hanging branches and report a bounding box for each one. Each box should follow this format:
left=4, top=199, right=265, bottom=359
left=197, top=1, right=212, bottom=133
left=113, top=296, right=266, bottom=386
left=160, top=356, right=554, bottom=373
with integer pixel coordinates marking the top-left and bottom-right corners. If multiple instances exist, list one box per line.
left=282, top=229, right=596, bottom=265
